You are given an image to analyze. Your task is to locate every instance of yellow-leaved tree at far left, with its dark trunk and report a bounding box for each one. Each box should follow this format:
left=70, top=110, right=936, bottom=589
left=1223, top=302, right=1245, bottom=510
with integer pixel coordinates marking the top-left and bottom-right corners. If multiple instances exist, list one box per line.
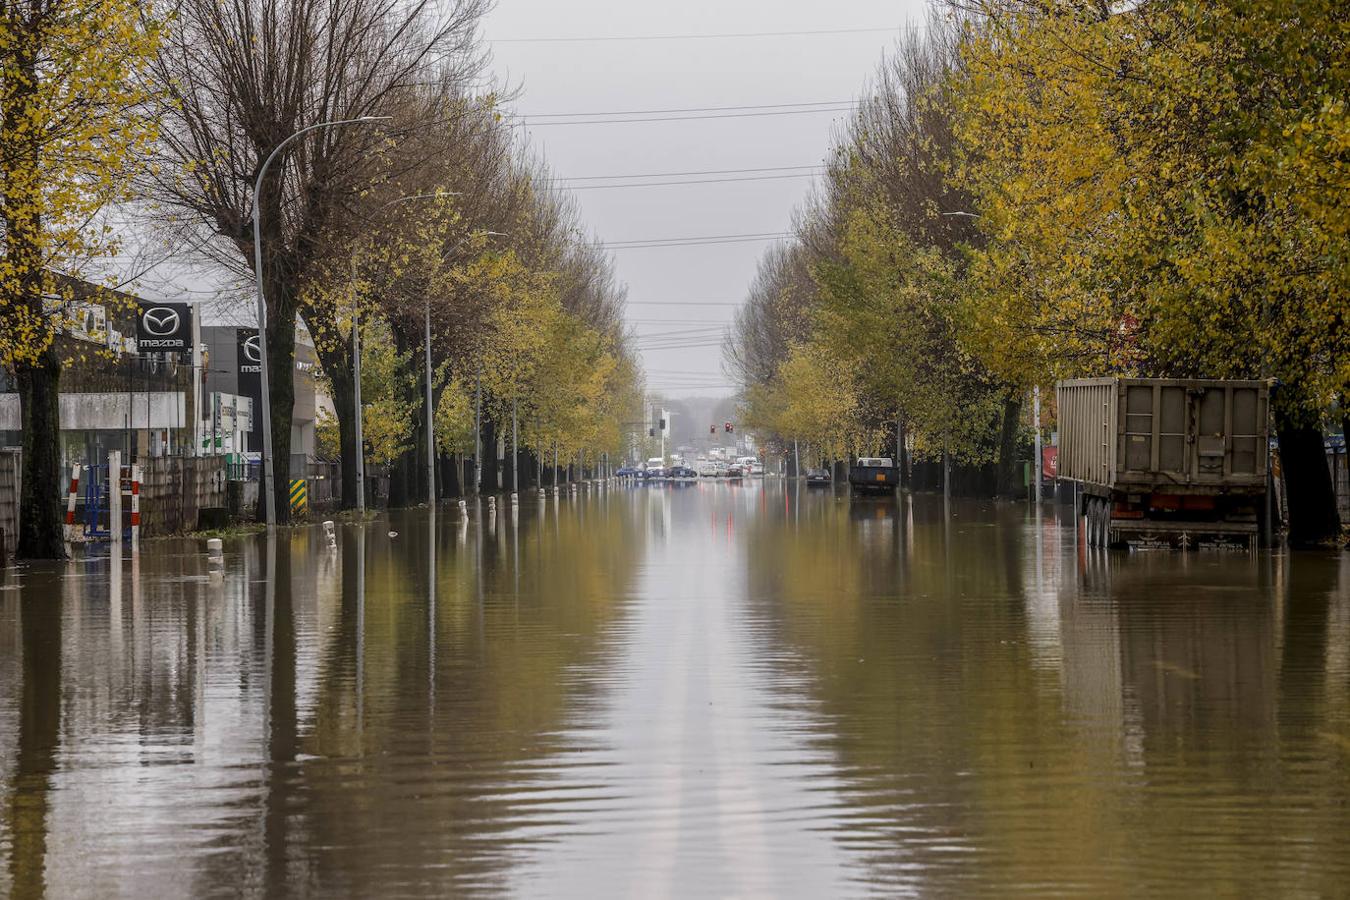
left=0, top=0, right=161, bottom=559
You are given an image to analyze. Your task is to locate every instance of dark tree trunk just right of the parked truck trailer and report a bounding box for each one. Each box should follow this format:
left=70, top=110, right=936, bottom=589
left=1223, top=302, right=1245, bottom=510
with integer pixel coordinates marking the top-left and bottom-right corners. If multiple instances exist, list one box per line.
left=1272, top=396, right=1341, bottom=546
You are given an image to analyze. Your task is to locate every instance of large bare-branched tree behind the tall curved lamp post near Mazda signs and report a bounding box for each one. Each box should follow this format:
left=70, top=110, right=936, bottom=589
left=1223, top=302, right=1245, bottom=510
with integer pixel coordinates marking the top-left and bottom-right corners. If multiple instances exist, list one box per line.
left=151, top=0, right=489, bottom=521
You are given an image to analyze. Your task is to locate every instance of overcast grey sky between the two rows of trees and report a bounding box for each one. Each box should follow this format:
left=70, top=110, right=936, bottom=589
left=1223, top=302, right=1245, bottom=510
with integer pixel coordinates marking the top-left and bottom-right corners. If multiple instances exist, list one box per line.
left=485, top=0, right=925, bottom=397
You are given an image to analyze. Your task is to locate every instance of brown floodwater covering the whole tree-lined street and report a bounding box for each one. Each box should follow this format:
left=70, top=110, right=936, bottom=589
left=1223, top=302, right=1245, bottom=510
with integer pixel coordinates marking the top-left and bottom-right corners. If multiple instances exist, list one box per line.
left=0, top=479, right=1350, bottom=899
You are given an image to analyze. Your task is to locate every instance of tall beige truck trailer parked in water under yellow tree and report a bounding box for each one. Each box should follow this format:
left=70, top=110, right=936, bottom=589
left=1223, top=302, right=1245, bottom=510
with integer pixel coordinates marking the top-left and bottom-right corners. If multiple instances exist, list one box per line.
left=1056, top=378, right=1270, bottom=549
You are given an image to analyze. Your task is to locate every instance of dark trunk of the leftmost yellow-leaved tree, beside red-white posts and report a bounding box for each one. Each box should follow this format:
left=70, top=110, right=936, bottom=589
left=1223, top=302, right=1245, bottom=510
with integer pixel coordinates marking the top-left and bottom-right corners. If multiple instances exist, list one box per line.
left=15, top=348, right=66, bottom=560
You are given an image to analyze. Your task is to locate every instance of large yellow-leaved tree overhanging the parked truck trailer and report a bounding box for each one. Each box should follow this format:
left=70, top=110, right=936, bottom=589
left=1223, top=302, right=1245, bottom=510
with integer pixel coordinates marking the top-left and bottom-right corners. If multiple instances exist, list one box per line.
left=957, top=0, right=1350, bottom=542
